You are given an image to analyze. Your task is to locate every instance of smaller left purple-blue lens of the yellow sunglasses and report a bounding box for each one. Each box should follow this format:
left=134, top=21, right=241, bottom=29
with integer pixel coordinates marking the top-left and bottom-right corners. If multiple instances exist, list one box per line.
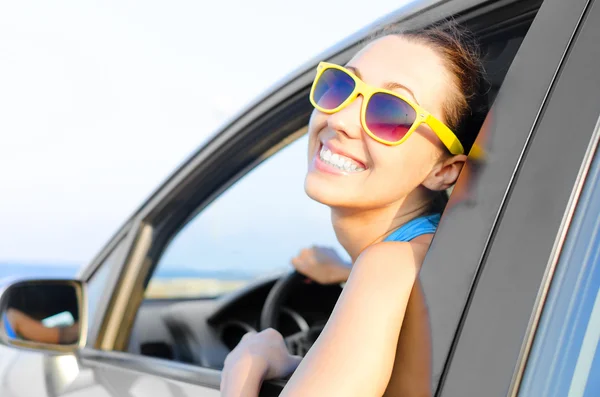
left=313, top=69, right=356, bottom=110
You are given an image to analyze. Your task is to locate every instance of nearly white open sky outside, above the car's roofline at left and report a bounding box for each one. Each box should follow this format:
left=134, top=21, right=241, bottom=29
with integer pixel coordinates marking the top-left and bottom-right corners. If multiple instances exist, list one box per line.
left=0, top=0, right=408, bottom=264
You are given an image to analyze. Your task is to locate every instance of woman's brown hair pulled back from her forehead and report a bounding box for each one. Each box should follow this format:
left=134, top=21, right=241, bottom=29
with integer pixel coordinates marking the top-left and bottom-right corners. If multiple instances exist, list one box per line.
left=367, top=20, right=489, bottom=153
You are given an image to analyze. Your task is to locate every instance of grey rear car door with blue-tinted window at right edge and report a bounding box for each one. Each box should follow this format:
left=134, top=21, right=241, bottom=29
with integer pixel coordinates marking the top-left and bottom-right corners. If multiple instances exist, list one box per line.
left=439, top=1, right=600, bottom=396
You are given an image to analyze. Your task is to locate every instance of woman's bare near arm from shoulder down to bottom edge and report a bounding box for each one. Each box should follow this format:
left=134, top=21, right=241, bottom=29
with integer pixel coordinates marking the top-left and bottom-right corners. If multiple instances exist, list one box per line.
left=282, top=242, right=428, bottom=397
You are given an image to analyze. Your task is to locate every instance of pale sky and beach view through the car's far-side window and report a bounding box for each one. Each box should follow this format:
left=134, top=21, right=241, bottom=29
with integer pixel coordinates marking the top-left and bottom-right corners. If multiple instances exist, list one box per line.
left=145, top=135, right=345, bottom=299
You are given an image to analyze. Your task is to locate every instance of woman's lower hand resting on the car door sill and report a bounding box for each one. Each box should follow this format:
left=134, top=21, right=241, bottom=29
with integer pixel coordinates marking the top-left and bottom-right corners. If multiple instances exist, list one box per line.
left=221, top=328, right=301, bottom=396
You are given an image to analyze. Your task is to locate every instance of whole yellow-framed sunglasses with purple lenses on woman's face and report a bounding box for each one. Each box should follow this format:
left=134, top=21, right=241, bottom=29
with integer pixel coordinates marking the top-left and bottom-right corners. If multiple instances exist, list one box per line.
left=310, top=62, right=464, bottom=154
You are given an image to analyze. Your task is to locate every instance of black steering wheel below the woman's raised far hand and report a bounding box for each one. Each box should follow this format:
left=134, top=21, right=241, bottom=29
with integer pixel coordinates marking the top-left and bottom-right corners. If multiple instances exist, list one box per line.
left=259, top=271, right=323, bottom=357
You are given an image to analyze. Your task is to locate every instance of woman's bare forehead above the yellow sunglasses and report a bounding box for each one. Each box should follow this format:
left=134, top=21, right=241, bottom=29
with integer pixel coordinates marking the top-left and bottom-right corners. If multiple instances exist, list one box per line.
left=347, top=35, right=448, bottom=113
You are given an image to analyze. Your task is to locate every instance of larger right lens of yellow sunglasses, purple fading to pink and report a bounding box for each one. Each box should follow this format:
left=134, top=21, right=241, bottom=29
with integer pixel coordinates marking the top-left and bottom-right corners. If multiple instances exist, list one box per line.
left=365, top=93, right=417, bottom=142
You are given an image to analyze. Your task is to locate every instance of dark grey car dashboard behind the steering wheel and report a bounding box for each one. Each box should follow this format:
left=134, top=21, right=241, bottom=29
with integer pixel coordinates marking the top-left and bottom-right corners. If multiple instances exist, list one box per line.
left=127, top=277, right=342, bottom=369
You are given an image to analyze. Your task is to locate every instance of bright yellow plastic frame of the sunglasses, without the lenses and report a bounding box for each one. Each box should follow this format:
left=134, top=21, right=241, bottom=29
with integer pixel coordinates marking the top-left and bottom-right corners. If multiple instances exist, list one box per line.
left=309, top=62, right=465, bottom=154
